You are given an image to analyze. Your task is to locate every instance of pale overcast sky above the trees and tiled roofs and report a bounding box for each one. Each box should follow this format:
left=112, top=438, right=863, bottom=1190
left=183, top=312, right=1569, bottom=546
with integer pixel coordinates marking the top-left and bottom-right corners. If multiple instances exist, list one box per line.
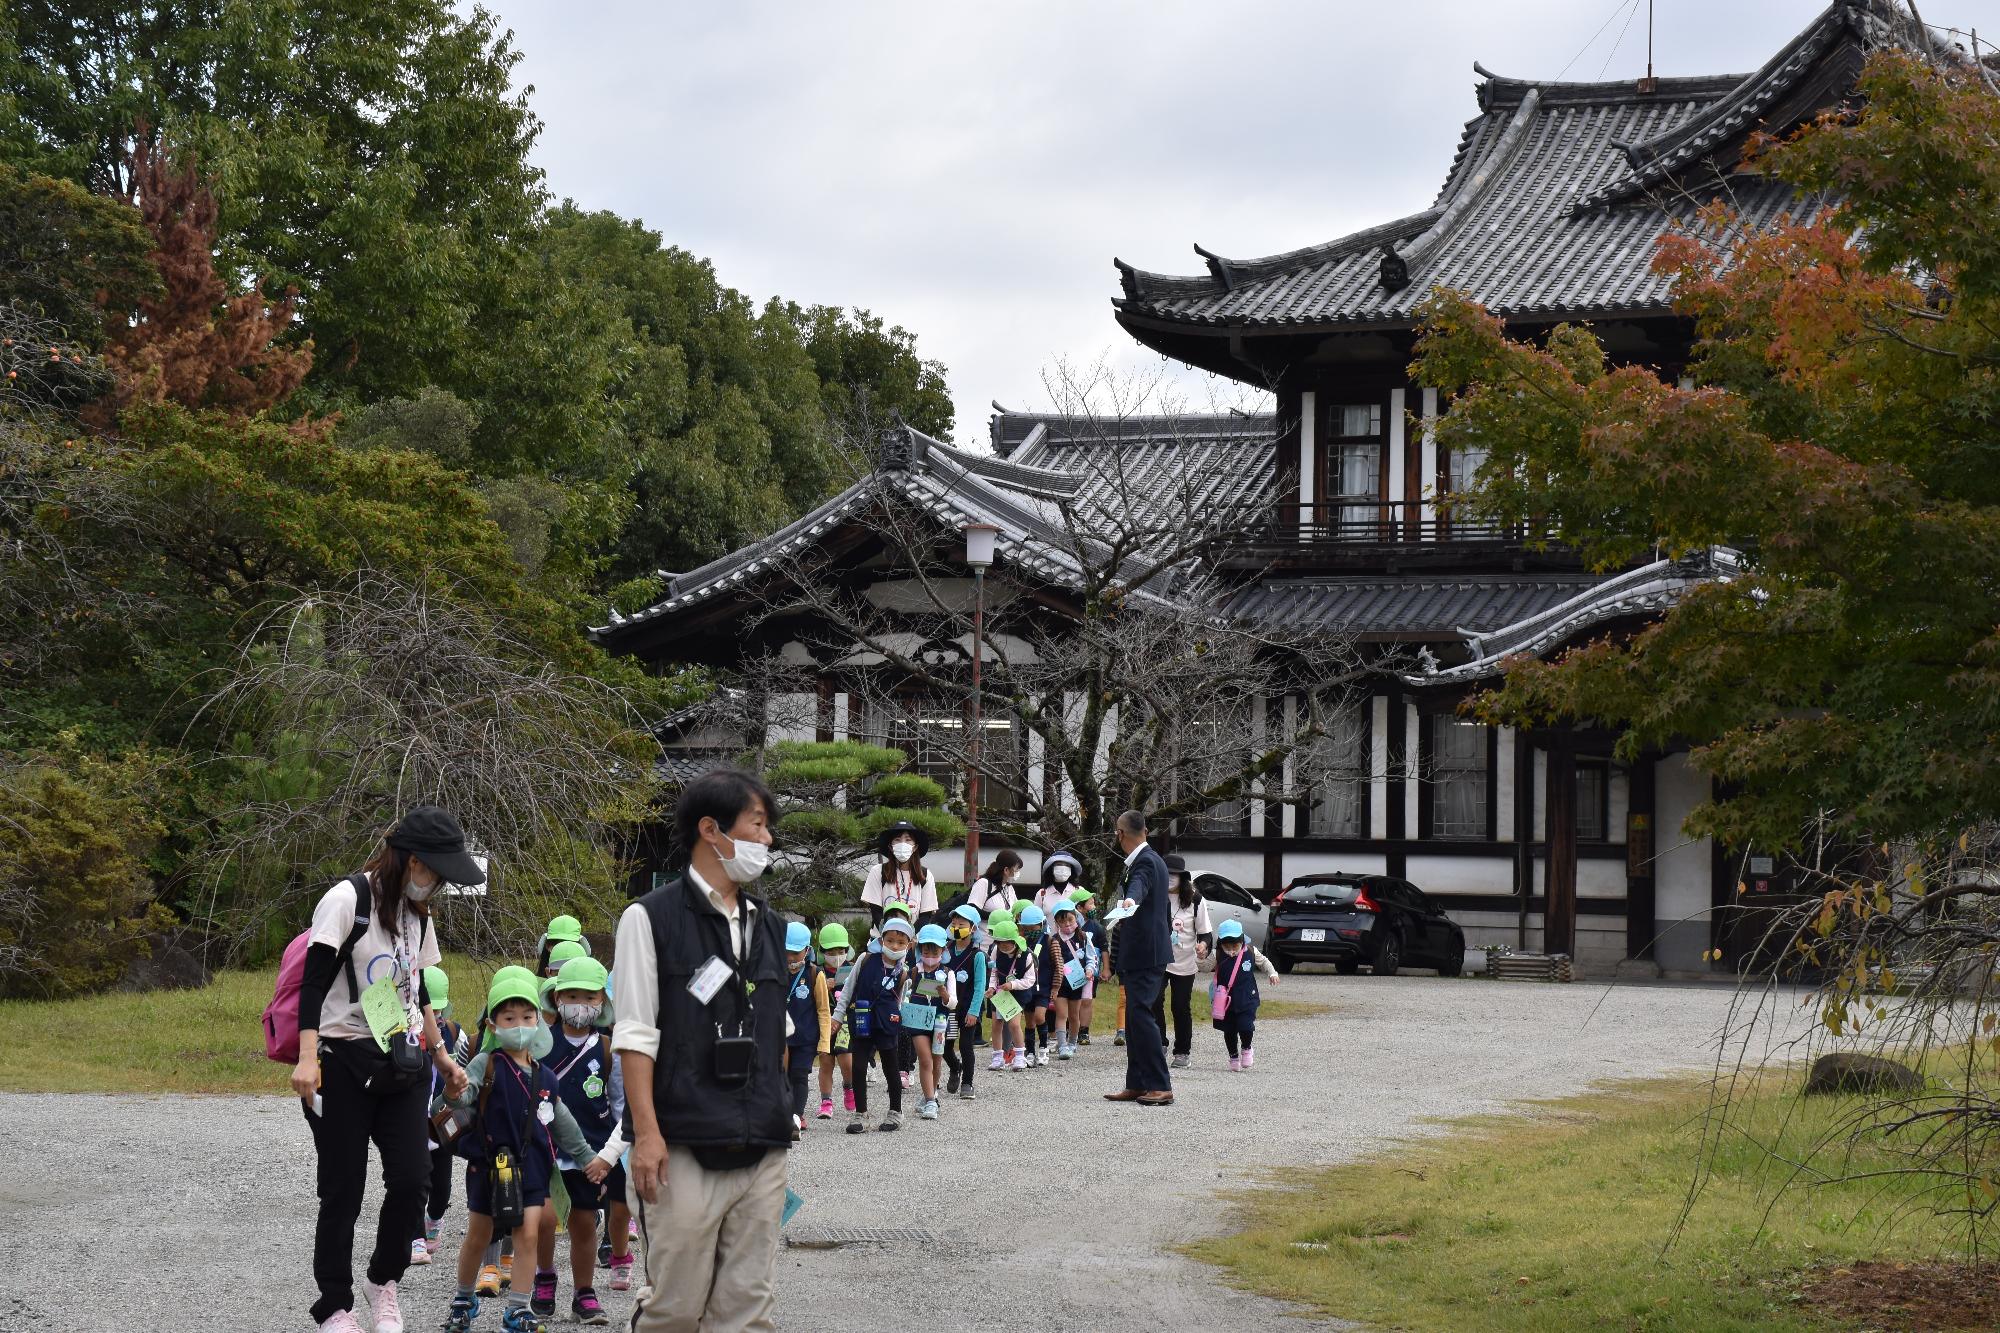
left=476, top=0, right=1944, bottom=444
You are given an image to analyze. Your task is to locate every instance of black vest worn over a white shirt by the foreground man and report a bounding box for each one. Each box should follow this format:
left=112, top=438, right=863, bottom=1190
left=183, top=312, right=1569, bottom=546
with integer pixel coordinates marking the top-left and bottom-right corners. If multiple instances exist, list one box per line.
left=638, top=875, right=792, bottom=1165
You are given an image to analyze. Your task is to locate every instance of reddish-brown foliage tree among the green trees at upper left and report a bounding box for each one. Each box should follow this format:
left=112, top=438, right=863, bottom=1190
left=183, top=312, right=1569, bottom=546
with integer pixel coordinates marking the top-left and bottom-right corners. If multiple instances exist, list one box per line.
left=96, top=130, right=312, bottom=420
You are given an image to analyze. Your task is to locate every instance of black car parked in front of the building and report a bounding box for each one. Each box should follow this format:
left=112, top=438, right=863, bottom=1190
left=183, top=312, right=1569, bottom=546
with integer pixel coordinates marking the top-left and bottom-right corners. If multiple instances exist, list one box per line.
left=1264, top=875, right=1466, bottom=977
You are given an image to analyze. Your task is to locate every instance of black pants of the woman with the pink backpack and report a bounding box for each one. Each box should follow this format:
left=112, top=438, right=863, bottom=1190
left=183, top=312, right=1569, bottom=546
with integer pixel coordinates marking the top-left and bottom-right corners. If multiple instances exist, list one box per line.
left=306, top=1041, right=430, bottom=1321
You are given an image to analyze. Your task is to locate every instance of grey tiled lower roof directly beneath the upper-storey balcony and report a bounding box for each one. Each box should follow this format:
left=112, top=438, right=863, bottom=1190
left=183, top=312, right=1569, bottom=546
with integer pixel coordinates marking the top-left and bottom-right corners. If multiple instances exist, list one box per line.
left=1230, top=574, right=1604, bottom=638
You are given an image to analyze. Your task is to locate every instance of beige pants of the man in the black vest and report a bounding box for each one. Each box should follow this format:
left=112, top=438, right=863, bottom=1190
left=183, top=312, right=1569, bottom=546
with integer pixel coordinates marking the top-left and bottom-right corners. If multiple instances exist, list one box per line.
left=630, top=1147, right=784, bottom=1333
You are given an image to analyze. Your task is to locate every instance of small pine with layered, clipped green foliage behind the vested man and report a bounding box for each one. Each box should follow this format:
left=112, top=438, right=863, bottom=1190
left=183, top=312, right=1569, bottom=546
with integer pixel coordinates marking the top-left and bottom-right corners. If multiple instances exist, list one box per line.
left=746, top=741, right=966, bottom=921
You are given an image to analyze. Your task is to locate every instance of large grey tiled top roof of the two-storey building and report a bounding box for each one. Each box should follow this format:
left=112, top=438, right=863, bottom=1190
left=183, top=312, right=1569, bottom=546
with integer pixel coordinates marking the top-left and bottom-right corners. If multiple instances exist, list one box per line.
left=1116, top=0, right=1928, bottom=328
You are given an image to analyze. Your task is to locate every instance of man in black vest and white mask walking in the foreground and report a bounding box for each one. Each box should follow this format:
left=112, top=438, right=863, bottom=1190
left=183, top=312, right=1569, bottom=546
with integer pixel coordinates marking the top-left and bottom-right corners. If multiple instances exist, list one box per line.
left=612, top=769, right=792, bottom=1333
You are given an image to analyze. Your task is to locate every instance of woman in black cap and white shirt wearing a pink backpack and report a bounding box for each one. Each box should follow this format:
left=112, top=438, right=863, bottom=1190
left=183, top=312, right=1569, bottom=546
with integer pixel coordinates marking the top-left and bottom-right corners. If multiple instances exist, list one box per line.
left=292, top=805, right=486, bottom=1333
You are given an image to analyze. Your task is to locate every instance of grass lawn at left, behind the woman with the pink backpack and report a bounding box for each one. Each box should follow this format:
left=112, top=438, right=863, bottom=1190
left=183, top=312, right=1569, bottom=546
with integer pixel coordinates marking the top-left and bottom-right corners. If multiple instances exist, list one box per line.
left=0, top=955, right=492, bottom=1093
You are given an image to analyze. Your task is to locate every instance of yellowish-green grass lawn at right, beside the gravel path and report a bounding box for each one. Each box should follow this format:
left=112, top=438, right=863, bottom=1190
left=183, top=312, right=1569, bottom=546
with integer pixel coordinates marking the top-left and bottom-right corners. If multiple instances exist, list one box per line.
left=1186, top=1067, right=1984, bottom=1333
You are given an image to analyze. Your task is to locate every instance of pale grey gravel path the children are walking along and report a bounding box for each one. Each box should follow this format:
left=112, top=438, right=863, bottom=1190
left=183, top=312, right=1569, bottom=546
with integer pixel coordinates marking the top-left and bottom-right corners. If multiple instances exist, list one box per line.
left=0, top=975, right=1804, bottom=1333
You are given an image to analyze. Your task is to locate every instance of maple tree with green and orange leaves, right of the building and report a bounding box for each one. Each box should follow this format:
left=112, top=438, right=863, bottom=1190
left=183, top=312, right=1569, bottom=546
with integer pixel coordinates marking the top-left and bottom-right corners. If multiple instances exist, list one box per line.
left=1420, top=54, right=2000, bottom=845
